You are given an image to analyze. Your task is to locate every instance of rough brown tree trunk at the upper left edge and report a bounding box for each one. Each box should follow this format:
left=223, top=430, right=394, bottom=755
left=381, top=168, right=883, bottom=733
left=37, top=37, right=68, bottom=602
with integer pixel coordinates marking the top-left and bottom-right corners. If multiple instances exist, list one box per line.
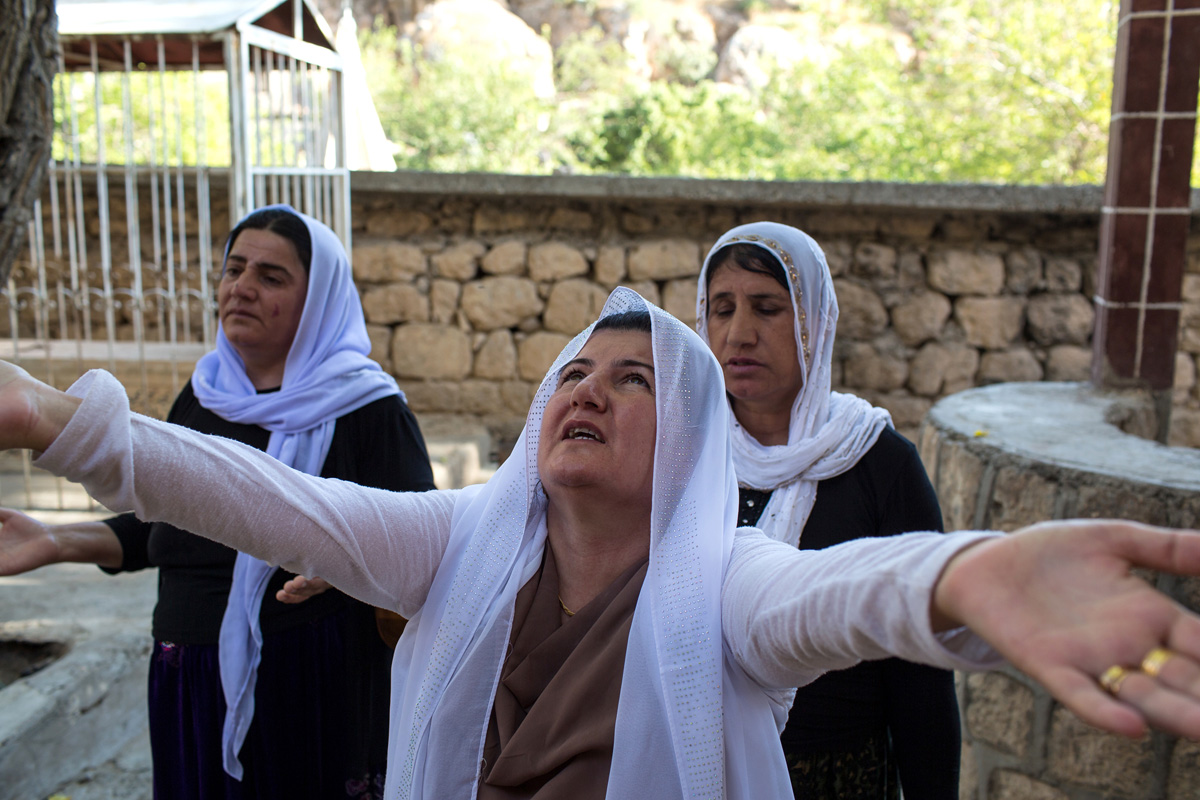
left=0, top=0, right=59, bottom=285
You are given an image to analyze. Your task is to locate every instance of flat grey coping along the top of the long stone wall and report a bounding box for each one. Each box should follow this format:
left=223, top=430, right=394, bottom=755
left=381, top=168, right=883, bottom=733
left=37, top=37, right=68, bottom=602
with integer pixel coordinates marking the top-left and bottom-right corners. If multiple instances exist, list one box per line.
left=350, top=170, right=1200, bottom=216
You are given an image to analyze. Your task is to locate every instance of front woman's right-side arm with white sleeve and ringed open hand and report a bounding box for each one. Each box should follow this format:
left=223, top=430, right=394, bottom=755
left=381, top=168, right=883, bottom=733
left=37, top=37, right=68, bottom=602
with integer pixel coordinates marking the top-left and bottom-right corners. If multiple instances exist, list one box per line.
left=722, top=521, right=1200, bottom=739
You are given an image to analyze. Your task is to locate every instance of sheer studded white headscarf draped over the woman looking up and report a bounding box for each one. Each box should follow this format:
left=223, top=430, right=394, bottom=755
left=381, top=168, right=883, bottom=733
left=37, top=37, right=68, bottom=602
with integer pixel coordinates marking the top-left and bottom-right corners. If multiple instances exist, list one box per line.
left=385, top=289, right=791, bottom=800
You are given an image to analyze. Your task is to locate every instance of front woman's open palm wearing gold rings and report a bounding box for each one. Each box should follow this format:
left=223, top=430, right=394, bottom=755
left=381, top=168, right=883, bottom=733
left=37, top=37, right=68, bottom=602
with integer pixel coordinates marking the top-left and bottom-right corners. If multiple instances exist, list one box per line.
left=934, top=521, right=1200, bottom=739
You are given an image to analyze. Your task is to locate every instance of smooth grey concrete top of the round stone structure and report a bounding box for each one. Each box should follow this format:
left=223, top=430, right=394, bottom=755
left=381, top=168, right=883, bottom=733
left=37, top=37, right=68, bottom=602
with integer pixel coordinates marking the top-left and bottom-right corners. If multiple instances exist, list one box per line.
left=929, top=383, right=1200, bottom=493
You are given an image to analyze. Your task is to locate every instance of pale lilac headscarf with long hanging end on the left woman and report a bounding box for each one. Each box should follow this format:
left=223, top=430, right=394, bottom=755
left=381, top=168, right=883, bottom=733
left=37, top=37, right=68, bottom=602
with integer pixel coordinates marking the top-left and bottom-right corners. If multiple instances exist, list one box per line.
left=192, top=205, right=402, bottom=780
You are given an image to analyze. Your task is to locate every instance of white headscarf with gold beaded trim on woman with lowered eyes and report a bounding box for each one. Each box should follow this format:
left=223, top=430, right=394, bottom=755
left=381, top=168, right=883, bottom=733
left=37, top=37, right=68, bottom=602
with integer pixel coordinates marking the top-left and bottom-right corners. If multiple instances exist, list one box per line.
left=696, top=222, right=892, bottom=547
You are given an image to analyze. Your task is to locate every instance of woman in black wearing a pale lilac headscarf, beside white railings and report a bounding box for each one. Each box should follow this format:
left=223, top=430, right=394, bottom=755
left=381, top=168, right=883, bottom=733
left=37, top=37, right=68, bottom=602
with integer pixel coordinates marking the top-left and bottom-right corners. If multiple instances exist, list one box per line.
left=0, top=205, right=433, bottom=800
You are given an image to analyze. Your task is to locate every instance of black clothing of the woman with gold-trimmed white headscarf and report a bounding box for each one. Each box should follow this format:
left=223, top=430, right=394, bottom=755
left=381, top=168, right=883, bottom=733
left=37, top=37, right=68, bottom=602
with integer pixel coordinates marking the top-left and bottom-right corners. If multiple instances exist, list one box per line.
left=738, top=428, right=961, bottom=800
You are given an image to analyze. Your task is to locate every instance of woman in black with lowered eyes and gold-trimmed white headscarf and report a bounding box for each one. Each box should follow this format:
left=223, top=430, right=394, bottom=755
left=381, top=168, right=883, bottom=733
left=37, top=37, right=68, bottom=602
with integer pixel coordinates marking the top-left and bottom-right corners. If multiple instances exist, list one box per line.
left=696, top=222, right=961, bottom=800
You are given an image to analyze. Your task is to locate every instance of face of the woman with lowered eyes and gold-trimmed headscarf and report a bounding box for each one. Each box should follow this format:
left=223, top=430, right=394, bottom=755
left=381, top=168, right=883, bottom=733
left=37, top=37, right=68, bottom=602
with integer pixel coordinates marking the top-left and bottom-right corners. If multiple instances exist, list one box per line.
left=706, top=263, right=804, bottom=413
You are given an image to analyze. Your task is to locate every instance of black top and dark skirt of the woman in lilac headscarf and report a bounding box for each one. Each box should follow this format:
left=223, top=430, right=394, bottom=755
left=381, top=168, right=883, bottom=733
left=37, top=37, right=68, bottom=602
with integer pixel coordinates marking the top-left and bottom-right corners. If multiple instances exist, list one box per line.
left=100, top=384, right=434, bottom=800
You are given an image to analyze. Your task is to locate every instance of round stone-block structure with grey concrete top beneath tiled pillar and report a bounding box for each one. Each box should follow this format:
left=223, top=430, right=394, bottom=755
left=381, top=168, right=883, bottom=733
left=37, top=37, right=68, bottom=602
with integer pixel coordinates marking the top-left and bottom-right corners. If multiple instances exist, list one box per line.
left=919, top=383, right=1200, bottom=800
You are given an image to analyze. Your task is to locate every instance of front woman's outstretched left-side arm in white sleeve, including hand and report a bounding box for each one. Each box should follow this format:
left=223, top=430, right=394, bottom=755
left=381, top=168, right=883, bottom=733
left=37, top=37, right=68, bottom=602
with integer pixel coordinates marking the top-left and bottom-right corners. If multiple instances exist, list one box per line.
left=0, top=363, right=456, bottom=615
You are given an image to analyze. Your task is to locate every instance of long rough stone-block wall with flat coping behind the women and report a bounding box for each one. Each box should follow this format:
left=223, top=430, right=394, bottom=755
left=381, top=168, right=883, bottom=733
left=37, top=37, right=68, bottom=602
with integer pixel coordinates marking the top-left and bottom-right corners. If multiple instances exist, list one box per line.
left=9, top=173, right=1200, bottom=452
